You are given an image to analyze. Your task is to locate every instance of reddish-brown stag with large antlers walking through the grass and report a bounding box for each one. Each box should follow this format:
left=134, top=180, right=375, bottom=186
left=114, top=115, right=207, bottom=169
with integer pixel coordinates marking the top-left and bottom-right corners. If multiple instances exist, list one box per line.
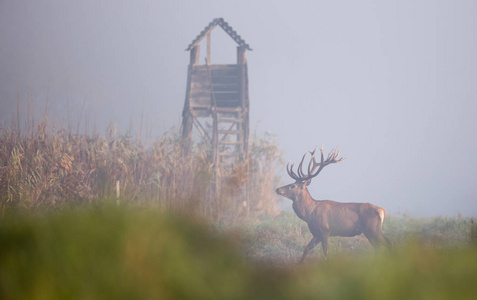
left=276, top=146, right=391, bottom=263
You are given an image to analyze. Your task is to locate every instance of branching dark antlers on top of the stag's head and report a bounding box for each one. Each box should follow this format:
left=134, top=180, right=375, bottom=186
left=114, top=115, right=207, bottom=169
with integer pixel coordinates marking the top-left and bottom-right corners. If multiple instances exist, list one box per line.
left=287, top=145, right=344, bottom=181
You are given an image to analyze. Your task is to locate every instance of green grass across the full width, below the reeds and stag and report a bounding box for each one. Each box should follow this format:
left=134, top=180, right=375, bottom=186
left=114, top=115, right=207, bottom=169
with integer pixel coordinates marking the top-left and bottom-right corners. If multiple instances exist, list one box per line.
left=0, top=205, right=477, bottom=299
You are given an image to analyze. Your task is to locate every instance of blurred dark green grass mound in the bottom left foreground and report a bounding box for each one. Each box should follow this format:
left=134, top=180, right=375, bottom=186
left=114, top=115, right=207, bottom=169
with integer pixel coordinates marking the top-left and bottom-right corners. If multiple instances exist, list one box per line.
left=0, top=207, right=255, bottom=299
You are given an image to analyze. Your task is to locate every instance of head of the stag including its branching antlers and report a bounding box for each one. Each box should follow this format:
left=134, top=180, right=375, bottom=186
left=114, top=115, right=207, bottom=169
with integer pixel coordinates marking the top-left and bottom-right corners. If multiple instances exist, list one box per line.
left=276, top=146, right=344, bottom=201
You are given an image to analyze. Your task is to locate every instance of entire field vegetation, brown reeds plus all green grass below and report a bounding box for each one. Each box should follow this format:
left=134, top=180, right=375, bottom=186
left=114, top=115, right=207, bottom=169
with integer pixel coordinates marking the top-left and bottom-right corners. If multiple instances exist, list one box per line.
left=0, top=118, right=477, bottom=300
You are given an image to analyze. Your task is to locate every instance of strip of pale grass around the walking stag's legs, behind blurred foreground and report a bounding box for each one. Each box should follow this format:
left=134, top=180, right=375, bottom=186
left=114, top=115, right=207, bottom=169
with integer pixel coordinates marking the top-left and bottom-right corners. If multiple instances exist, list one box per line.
left=241, top=212, right=471, bottom=265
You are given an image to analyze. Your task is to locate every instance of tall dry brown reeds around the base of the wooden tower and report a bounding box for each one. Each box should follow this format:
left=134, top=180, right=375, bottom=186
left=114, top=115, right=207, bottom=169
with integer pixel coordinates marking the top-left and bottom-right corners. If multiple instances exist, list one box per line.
left=0, top=118, right=281, bottom=222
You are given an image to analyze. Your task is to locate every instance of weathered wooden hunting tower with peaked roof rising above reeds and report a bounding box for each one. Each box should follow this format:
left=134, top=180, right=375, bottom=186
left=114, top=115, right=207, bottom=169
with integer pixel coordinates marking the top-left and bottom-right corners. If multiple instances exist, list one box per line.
left=182, top=18, right=252, bottom=166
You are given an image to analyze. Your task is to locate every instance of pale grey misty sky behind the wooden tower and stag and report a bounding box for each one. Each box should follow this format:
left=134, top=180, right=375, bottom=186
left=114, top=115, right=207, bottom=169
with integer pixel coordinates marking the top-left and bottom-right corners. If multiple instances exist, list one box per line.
left=0, top=0, right=477, bottom=216
